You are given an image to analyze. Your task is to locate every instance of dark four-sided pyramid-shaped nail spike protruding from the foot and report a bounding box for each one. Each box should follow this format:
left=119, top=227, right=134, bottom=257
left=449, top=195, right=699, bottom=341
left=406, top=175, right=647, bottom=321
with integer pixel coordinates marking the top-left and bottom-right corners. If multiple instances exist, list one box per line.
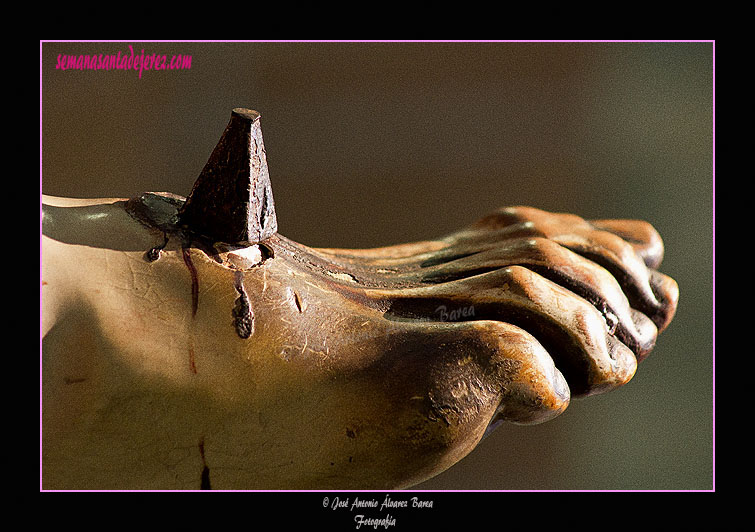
left=179, top=108, right=278, bottom=246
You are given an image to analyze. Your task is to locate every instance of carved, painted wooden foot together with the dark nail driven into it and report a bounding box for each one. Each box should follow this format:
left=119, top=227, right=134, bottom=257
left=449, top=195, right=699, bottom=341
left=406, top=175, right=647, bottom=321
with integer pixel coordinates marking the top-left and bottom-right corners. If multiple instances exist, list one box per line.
left=42, top=110, right=678, bottom=489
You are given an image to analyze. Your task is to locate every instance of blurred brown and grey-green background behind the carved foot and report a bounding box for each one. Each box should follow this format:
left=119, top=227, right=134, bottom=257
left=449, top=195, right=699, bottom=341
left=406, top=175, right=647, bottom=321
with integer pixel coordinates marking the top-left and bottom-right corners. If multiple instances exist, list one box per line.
left=42, top=42, right=714, bottom=490
